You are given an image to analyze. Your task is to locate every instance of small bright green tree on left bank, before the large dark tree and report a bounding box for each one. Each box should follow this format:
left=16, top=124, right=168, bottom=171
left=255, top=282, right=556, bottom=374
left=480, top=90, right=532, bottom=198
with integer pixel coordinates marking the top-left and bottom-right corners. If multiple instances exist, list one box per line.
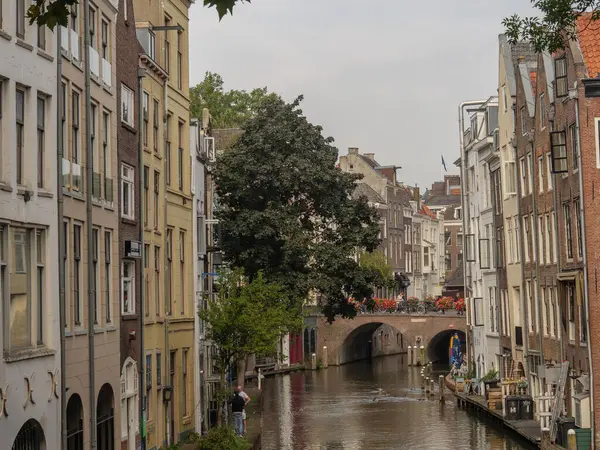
left=199, top=269, right=302, bottom=424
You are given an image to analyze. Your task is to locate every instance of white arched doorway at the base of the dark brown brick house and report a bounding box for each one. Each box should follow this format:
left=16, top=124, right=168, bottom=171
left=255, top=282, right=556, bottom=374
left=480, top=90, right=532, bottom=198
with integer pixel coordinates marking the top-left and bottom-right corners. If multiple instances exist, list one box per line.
left=121, top=358, right=139, bottom=450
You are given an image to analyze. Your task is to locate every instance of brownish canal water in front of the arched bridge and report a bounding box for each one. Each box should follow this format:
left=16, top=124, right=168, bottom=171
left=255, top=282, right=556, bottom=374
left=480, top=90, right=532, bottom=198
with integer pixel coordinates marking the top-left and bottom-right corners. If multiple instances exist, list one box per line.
left=261, top=355, right=532, bottom=450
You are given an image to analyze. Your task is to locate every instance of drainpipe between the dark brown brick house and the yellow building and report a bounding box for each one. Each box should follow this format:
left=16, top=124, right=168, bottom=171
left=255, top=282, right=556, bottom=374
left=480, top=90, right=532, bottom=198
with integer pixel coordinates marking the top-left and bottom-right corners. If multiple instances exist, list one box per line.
left=137, top=67, right=150, bottom=450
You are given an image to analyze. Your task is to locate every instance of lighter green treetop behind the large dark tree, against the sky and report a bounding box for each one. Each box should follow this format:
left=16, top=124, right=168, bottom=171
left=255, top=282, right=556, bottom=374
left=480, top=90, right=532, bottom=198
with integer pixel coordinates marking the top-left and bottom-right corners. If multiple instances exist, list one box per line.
left=190, top=72, right=278, bottom=128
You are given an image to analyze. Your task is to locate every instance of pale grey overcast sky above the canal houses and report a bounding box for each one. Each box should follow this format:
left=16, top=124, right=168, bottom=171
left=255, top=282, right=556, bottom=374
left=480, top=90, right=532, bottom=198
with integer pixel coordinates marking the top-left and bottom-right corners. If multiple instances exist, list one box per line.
left=190, top=0, right=531, bottom=187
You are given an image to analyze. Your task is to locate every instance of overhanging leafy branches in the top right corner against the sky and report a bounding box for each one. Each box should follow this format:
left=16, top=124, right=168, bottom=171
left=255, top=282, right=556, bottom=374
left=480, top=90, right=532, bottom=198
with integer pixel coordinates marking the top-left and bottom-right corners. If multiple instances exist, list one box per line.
left=502, top=0, right=600, bottom=52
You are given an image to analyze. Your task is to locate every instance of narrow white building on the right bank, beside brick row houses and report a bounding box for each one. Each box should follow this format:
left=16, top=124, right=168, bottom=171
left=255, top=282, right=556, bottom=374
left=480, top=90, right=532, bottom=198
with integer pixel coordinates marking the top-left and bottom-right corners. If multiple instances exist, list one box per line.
left=460, top=97, right=503, bottom=384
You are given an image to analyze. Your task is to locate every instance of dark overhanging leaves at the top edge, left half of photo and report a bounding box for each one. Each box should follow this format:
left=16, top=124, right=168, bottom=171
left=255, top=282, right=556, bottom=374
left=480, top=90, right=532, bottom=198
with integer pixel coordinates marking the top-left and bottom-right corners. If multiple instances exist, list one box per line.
left=27, top=0, right=250, bottom=30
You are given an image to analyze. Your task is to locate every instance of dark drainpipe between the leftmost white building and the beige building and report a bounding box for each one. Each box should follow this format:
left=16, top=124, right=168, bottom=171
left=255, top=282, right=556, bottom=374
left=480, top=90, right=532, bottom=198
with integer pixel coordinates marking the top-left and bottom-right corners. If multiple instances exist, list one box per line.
left=56, top=26, right=67, bottom=448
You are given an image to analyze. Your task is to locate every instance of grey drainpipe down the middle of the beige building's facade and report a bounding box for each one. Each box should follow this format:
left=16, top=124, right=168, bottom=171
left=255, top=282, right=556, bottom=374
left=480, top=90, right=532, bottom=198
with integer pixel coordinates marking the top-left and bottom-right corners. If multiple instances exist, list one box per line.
left=84, top=0, right=97, bottom=450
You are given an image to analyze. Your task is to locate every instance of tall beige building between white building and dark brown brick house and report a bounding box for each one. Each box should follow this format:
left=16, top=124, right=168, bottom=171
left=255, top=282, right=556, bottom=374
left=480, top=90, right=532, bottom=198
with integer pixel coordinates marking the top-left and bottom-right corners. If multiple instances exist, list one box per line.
left=58, top=0, right=125, bottom=449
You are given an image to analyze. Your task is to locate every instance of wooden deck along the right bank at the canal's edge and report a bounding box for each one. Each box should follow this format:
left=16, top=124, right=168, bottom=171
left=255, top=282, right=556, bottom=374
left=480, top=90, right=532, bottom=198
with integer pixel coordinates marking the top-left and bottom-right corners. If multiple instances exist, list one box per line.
left=454, top=392, right=564, bottom=450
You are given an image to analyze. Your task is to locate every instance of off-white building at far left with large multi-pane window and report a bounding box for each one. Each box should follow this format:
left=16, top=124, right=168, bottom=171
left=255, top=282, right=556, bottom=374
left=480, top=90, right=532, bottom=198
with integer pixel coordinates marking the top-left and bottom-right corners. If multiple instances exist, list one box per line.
left=0, top=7, right=61, bottom=449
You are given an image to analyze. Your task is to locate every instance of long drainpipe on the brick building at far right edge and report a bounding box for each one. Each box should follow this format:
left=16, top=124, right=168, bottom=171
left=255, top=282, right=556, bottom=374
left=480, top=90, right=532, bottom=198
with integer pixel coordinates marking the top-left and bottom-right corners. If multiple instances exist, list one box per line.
left=569, top=87, right=596, bottom=449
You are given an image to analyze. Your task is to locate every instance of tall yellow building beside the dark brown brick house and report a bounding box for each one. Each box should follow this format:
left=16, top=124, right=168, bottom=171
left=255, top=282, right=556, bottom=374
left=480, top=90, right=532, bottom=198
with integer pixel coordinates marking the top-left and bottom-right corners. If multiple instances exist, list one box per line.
left=134, top=0, right=196, bottom=449
